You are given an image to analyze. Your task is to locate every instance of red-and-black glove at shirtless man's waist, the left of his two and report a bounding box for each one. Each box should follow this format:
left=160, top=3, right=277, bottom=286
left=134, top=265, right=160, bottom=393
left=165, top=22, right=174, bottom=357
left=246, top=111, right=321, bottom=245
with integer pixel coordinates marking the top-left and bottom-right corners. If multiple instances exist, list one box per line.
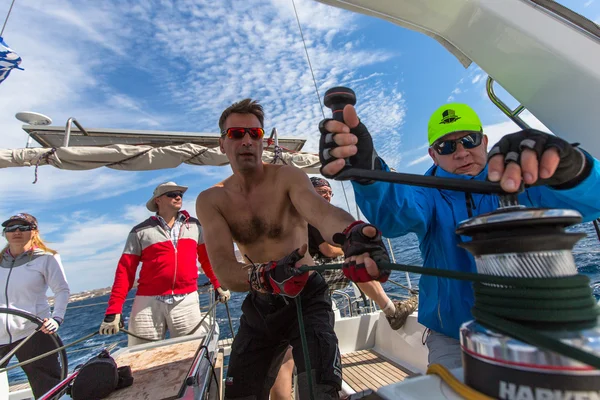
left=249, top=249, right=308, bottom=297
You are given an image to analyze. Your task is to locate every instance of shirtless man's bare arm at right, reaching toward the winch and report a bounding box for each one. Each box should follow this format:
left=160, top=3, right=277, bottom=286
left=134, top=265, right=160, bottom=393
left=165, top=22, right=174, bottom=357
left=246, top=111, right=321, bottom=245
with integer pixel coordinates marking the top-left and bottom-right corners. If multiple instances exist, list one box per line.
left=280, top=166, right=354, bottom=244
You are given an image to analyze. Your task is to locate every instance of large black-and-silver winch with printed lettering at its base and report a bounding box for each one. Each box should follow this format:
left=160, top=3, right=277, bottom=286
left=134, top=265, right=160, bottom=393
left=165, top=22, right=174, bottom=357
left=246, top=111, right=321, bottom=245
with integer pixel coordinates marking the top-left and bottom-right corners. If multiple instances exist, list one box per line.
left=456, top=202, right=600, bottom=400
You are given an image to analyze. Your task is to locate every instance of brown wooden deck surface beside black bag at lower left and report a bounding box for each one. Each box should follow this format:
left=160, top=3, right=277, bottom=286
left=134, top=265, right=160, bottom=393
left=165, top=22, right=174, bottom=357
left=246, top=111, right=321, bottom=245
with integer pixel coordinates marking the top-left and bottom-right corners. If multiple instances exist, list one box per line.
left=107, top=339, right=202, bottom=400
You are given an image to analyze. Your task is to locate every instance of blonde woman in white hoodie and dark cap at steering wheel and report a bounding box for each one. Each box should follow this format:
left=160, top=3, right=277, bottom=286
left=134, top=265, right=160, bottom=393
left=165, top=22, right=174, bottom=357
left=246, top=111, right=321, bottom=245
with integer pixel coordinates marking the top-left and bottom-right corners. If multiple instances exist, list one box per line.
left=0, top=213, right=70, bottom=399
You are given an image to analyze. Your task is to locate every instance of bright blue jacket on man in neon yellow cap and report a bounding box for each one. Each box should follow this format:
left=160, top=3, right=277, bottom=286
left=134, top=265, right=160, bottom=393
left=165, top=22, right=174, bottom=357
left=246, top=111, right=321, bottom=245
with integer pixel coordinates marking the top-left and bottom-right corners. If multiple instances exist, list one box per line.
left=352, top=157, right=600, bottom=339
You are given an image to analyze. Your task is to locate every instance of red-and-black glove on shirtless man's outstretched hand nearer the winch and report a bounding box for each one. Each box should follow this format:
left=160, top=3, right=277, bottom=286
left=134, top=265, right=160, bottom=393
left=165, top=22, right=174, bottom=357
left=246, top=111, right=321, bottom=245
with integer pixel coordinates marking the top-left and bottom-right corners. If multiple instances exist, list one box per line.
left=333, top=221, right=391, bottom=283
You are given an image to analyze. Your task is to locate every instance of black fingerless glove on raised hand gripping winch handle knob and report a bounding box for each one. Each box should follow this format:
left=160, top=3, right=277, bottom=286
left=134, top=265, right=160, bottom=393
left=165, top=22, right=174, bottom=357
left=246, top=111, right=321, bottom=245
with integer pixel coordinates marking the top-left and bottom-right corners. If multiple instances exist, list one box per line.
left=319, top=118, right=382, bottom=185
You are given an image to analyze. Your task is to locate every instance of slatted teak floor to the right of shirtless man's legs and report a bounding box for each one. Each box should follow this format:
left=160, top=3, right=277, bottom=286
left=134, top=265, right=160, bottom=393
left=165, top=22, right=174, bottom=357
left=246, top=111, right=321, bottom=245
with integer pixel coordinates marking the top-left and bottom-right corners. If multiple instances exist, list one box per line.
left=342, top=350, right=418, bottom=392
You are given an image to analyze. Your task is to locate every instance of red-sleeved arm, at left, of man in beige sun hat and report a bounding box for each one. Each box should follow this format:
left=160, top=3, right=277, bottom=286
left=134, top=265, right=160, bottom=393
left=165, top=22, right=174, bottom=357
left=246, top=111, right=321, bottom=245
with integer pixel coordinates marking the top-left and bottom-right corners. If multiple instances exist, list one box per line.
left=106, top=232, right=142, bottom=315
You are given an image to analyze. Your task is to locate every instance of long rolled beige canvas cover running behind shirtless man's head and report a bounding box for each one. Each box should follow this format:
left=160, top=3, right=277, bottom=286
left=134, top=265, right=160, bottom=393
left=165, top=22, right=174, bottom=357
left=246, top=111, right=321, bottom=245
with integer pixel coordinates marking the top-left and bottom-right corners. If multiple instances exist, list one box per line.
left=0, top=143, right=321, bottom=174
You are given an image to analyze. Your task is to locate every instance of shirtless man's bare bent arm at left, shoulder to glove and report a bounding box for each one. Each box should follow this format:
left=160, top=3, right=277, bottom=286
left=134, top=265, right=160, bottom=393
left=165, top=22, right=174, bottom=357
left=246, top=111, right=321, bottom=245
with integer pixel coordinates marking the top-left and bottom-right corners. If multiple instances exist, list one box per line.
left=196, top=188, right=250, bottom=292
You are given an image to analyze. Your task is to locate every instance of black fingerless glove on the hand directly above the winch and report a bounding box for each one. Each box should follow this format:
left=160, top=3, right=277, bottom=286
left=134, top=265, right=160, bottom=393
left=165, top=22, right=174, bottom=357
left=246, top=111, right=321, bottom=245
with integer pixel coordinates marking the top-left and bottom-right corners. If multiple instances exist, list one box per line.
left=488, top=129, right=593, bottom=189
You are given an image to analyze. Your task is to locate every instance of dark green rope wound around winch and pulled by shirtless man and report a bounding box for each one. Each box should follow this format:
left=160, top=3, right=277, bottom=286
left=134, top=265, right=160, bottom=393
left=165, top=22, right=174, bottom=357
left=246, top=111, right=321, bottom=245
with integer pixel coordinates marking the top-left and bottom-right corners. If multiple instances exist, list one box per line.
left=300, top=263, right=600, bottom=368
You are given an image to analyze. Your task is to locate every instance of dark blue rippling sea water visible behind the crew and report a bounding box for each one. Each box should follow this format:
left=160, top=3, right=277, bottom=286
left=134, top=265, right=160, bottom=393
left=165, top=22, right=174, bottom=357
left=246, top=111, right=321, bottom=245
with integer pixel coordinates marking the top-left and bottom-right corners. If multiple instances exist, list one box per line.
left=9, top=223, right=600, bottom=383
